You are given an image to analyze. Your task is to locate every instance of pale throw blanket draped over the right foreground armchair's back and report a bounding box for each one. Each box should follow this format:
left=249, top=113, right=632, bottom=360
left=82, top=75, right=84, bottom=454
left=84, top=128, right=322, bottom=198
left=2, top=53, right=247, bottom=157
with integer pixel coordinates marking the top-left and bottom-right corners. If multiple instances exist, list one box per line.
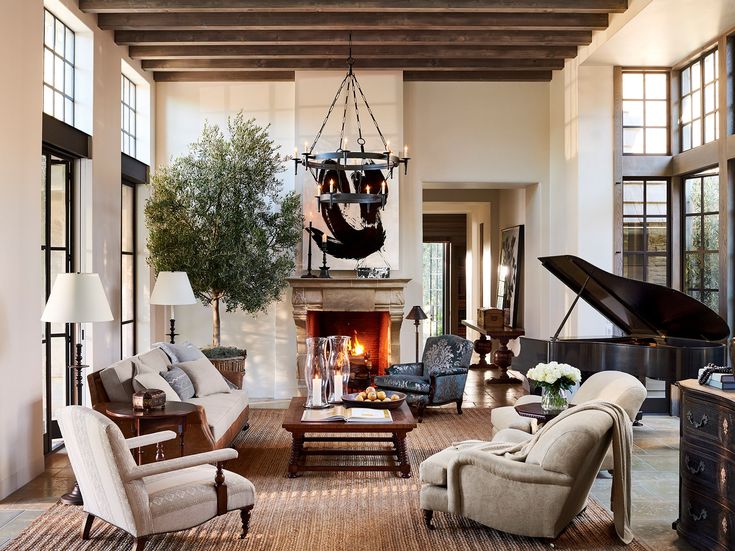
left=454, top=401, right=633, bottom=544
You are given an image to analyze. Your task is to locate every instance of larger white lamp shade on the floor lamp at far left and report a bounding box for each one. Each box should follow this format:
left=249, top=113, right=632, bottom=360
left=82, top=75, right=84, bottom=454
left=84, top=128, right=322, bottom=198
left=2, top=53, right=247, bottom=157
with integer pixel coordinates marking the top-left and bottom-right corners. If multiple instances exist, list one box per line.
left=41, top=274, right=113, bottom=323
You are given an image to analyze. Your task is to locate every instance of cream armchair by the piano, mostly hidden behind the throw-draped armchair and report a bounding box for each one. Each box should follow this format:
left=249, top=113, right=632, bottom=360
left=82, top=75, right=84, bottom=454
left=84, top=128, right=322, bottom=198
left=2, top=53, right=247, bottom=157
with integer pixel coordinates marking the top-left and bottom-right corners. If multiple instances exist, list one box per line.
left=490, top=371, right=647, bottom=470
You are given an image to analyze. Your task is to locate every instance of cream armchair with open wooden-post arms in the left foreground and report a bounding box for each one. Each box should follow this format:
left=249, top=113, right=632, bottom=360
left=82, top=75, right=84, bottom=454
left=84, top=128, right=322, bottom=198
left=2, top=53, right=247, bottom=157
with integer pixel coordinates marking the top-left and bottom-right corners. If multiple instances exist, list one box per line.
left=59, top=406, right=255, bottom=551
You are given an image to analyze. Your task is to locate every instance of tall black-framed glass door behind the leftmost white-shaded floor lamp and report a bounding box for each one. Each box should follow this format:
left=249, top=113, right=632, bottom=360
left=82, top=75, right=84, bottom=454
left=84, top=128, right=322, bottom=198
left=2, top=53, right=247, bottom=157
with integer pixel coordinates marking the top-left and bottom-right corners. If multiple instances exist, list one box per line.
left=41, top=149, right=74, bottom=453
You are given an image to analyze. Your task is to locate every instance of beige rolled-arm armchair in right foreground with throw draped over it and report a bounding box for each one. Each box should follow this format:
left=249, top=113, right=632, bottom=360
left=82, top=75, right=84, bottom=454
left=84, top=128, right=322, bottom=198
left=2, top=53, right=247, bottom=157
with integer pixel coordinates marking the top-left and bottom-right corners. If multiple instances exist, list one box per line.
left=419, top=411, right=613, bottom=538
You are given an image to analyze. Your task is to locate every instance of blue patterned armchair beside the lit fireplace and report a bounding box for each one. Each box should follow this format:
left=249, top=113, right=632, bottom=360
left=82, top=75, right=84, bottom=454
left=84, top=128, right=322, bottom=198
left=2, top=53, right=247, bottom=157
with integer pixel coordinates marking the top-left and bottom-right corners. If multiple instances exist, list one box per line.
left=375, top=335, right=472, bottom=423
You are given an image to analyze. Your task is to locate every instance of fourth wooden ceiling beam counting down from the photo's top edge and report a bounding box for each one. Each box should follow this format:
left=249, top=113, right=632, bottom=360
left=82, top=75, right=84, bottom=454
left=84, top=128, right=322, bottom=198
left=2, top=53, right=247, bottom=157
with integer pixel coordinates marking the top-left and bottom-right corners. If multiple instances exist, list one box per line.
left=129, top=45, right=577, bottom=60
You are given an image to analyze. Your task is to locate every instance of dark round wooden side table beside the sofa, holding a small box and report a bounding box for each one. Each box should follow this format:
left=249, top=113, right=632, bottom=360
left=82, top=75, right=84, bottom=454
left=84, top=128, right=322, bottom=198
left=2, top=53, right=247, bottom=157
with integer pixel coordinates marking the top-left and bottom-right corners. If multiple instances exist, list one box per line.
left=105, top=402, right=197, bottom=465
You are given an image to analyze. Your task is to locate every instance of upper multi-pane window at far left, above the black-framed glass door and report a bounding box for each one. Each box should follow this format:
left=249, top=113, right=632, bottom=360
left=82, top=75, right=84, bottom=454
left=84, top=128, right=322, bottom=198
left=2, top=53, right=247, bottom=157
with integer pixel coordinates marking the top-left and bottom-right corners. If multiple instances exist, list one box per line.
left=43, top=10, right=74, bottom=125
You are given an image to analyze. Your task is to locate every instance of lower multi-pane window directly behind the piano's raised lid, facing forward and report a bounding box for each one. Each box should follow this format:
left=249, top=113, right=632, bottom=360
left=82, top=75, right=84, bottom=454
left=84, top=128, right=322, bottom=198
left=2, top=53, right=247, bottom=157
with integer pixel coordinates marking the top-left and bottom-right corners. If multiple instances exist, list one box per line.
left=623, top=179, right=669, bottom=285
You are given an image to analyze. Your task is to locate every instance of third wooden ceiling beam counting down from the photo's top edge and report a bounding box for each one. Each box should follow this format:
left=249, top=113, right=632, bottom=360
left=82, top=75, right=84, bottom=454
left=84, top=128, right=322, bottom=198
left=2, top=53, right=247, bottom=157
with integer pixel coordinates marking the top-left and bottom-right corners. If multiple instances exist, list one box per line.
left=115, top=30, right=592, bottom=48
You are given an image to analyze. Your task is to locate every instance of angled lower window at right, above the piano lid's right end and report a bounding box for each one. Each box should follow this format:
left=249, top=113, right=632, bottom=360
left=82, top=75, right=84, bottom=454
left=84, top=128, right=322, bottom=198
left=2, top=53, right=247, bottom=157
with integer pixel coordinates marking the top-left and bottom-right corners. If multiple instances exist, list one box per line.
left=683, top=169, right=720, bottom=312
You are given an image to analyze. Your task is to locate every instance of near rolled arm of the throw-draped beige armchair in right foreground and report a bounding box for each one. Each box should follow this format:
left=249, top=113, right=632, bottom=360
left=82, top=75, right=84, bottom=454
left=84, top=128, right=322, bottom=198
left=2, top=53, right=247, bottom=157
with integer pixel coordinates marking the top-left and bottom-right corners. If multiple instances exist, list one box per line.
left=447, top=449, right=574, bottom=486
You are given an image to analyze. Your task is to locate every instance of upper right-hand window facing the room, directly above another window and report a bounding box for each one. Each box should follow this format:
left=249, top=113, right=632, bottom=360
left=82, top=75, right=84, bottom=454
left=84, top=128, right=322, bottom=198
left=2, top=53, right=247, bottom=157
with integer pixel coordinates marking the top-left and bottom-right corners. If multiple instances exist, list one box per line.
left=623, top=71, right=669, bottom=155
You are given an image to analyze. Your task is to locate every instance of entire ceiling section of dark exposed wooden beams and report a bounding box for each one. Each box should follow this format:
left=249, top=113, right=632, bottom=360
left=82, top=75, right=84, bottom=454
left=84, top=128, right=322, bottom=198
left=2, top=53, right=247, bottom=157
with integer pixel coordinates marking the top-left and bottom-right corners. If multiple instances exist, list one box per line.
left=79, top=0, right=627, bottom=81
